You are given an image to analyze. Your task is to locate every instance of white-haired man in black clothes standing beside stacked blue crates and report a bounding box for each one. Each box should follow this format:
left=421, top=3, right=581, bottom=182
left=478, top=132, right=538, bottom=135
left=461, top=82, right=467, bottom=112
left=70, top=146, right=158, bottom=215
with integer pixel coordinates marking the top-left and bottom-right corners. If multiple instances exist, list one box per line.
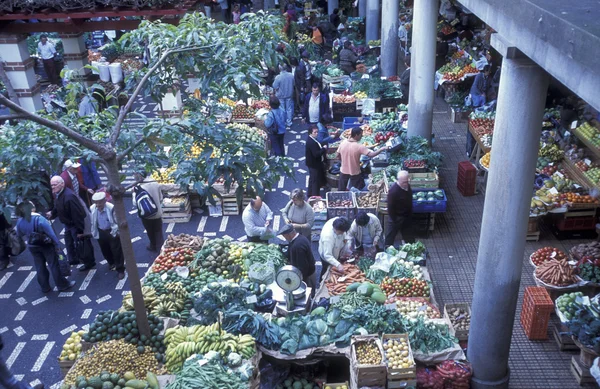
left=385, top=170, right=412, bottom=246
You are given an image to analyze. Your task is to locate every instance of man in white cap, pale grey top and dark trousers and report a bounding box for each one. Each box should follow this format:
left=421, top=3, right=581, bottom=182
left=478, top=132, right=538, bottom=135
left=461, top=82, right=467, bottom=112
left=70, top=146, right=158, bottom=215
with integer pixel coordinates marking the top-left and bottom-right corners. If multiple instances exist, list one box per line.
left=90, top=192, right=125, bottom=280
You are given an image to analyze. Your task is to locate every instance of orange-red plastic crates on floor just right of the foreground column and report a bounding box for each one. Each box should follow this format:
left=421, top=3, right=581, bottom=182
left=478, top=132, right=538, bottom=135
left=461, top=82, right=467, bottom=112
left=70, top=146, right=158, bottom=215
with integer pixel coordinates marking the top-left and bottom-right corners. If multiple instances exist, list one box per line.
left=521, top=286, right=554, bottom=340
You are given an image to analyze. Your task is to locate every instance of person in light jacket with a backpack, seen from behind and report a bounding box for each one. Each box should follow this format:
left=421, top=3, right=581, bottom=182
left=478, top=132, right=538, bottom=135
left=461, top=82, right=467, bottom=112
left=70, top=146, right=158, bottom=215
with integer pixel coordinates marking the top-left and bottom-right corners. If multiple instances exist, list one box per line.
left=132, top=169, right=163, bottom=252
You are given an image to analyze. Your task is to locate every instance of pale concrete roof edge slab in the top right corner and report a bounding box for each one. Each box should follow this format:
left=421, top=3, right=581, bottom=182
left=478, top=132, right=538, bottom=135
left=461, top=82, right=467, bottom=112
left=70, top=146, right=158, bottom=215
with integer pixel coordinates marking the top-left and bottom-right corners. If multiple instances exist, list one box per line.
left=459, top=0, right=600, bottom=110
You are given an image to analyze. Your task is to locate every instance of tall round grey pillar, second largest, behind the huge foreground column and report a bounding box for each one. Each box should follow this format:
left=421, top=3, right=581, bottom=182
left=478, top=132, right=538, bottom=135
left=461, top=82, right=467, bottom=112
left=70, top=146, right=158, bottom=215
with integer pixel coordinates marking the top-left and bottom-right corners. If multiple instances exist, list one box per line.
left=408, top=0, right=439, bottom=140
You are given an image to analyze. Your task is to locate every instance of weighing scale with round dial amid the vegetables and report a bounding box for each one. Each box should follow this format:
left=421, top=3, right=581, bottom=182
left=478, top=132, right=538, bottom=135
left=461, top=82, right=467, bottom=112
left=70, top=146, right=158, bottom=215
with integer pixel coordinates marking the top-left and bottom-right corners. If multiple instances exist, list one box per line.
left=269, top=265, right=310, bottom=316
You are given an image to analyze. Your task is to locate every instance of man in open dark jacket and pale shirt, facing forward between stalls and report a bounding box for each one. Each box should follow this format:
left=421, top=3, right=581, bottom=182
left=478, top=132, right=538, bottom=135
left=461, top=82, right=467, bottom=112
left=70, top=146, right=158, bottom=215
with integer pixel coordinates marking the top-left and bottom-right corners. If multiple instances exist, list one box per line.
left=302, top=82, right=340, bottom=145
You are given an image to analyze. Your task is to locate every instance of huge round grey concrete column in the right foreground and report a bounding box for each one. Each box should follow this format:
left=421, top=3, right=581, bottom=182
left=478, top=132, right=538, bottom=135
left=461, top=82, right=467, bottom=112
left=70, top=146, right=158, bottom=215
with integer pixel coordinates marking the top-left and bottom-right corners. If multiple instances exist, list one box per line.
left=468, top=54, right=548, bottom=389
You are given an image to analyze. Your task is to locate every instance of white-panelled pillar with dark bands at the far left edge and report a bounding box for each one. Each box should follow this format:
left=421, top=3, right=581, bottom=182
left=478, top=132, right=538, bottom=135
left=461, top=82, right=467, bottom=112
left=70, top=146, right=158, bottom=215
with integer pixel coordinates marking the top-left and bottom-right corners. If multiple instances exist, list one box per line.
left=0, top=34, right=44, bottom=112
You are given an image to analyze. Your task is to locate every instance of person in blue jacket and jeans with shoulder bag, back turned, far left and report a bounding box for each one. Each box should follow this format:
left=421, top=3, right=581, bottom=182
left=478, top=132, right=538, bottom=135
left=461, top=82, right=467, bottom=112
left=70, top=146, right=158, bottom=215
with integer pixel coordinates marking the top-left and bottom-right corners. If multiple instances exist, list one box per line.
left=15, top=202, right=75, bottom=293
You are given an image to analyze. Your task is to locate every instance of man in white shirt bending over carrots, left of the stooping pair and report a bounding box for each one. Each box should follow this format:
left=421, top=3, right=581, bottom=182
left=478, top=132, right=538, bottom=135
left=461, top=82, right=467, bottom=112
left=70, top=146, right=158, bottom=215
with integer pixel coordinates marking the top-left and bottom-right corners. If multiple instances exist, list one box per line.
left=319, top=217, right=350, bottom=274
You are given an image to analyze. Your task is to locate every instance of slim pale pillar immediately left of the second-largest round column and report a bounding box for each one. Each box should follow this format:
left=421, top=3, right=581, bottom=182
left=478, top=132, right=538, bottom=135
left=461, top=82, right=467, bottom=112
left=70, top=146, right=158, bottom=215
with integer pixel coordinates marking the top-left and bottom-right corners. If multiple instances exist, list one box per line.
left=381, top=0, right=398, bottom=77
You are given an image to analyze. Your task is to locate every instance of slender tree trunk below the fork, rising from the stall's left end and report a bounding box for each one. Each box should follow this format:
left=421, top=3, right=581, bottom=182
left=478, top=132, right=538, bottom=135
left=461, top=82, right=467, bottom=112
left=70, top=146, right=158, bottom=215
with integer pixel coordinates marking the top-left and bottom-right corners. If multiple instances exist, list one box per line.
left=105, top=158, right=151, bottom=337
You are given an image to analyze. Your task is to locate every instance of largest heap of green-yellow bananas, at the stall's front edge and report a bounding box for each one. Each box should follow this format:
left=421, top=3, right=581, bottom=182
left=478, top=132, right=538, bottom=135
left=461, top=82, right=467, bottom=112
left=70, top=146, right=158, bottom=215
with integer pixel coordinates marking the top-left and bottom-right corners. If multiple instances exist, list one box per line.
left=165, top=323, right=256, bottom=372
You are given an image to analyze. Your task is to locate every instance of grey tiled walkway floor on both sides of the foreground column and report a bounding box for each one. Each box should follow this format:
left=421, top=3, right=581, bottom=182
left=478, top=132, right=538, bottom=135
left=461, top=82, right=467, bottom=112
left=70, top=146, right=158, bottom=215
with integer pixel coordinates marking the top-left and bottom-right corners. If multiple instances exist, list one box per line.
left=422, top=98, right=596, bottom=389
